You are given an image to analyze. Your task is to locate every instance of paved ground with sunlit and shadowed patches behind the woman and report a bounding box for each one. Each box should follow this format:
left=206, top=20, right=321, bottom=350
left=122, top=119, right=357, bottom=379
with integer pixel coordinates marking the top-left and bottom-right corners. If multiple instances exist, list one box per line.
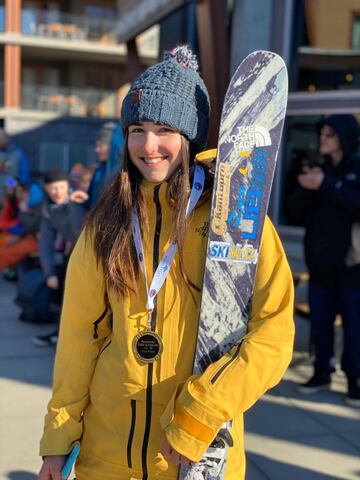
left=0, top=274, right=360, bottom=480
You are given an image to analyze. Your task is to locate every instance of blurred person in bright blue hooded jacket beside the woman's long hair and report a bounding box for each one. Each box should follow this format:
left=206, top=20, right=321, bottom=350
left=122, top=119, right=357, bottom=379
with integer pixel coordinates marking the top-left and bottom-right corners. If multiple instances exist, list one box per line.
left=71, top=122, right=124, bottom=210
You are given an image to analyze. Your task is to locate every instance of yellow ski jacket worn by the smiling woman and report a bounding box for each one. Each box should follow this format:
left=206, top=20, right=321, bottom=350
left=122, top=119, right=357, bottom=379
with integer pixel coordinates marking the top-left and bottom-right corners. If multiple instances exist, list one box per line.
left=40, top=182, right=294, bottom=480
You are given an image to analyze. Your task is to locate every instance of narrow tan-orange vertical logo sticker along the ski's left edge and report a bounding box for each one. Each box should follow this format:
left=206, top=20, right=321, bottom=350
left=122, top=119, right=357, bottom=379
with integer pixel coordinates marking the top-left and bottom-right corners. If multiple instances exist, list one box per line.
left=211, top=163, right=231, bottom=235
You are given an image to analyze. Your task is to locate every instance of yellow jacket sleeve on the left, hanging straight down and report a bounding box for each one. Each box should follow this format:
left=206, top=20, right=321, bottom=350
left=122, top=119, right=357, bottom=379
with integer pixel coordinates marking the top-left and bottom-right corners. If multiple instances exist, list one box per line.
left=40, top=233, right=111, bottom=456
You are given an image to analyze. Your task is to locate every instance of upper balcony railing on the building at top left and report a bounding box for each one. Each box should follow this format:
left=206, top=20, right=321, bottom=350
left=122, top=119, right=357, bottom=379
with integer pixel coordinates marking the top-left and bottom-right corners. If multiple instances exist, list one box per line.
left=21, top=8, right=118, bottom=44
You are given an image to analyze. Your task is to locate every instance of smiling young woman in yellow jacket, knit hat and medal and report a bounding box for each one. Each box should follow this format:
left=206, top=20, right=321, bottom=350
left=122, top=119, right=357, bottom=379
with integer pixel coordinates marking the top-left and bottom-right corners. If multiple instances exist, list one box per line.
left=39, top=47, right=294, bottom=480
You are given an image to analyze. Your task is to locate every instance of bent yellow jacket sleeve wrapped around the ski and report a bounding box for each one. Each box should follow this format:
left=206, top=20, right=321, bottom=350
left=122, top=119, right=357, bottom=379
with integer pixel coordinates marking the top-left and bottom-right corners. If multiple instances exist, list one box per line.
left=161, top=219, right=294, bottom=462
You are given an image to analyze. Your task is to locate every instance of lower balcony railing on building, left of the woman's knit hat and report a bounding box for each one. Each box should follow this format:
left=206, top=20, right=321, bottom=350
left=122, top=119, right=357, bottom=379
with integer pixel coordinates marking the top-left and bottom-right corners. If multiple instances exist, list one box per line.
left=21, top=85, right=120, bottom=117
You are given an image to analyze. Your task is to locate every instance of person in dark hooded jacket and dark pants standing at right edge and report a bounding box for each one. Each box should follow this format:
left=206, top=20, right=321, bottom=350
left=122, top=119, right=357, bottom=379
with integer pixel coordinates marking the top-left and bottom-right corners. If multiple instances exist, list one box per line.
left=290, top=115, right=360, bottom=406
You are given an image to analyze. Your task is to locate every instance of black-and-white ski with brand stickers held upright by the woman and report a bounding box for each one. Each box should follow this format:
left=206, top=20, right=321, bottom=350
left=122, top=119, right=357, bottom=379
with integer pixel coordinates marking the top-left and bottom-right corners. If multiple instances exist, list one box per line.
left=179, top=51, right=288, bottom=480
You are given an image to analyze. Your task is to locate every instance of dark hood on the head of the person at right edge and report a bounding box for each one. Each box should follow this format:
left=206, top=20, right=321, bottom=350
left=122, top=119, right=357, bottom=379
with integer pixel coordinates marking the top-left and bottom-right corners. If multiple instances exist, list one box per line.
left=318, top=114, right=360, bottom=156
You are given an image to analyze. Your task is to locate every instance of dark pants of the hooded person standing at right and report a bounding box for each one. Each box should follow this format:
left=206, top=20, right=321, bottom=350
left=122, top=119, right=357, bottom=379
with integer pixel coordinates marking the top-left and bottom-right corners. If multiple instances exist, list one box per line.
left=309, top=282, right=360, bottom=378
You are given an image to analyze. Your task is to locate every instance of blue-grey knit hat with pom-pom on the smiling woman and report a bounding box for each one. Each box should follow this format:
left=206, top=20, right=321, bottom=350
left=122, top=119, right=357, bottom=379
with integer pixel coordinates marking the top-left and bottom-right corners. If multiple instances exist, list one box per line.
left=121, top=46, right=210, bottom=151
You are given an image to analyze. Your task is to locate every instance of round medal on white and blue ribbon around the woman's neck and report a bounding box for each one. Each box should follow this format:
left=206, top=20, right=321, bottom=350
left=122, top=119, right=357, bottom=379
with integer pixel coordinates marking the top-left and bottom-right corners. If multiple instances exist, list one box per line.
left=132, top=165, right=205, bottom=363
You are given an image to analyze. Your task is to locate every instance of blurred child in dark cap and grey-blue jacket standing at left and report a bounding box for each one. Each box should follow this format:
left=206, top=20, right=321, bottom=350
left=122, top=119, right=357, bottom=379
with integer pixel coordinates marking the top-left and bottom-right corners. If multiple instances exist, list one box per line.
left=33, top=169, right=83, bottom=346
